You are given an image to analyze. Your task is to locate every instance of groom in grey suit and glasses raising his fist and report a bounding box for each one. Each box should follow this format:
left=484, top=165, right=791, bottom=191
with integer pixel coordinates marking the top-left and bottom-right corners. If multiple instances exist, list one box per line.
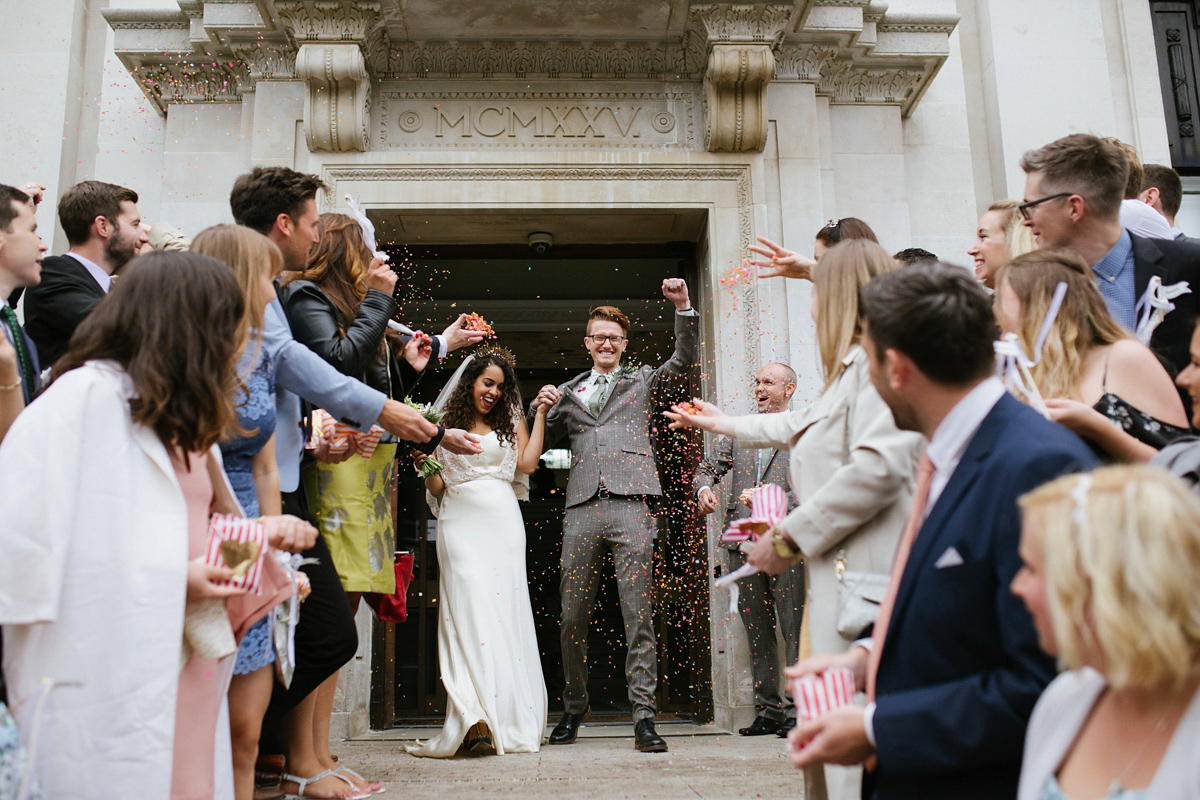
left=533, top=278, right=700, bottom=753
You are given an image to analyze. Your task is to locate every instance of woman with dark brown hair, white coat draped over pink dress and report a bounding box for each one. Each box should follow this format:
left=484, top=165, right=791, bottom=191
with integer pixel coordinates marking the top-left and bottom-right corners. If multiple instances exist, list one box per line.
left=0, top=253, right=316, bottom=799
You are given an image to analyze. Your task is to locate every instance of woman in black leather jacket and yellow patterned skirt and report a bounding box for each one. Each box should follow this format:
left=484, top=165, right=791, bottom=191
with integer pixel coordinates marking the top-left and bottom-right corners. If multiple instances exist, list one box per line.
left=280, top=213, right=432, bottom=789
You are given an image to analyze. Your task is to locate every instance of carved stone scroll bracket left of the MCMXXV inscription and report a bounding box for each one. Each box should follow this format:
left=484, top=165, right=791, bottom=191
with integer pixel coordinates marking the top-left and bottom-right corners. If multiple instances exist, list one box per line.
left=296, top=42, right=371, bottom=151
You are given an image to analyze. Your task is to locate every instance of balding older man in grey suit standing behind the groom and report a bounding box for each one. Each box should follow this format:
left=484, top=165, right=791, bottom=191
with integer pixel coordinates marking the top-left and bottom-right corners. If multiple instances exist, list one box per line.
left=692, top=363, right=804, bottom=736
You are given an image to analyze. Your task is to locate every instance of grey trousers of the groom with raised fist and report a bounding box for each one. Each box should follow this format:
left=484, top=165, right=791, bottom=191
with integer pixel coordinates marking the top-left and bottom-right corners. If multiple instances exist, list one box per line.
left=562, top=494, right=658, bottom=722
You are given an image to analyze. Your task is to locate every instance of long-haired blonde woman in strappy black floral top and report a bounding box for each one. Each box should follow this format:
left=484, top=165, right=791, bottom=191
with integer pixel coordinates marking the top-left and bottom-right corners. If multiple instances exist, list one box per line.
left=995, top=251, right=1188, bottom=462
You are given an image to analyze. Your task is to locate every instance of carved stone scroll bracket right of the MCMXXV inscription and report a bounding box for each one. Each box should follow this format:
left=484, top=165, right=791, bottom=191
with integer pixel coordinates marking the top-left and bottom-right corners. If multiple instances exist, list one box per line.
left=704, top=44, right=775, bottom=152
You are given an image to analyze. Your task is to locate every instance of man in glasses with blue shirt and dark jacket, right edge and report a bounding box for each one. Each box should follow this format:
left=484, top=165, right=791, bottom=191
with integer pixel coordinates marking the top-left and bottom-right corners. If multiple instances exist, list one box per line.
left=1019, top=133, right=1200, bottom=372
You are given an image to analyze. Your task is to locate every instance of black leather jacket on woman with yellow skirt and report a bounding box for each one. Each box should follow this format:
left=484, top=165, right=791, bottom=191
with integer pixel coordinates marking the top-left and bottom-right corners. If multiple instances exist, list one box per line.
left=280, top=281, right=421, bottom=399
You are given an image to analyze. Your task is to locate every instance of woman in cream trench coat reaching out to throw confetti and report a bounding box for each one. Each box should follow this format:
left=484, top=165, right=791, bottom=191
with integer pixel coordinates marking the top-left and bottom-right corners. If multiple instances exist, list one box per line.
left=667, top=240, right=924, bottom=798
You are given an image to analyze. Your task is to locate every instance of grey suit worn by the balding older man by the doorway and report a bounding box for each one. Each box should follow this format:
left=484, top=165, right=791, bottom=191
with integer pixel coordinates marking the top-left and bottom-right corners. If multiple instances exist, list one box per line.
left=692, top=437, right=804, bottom=722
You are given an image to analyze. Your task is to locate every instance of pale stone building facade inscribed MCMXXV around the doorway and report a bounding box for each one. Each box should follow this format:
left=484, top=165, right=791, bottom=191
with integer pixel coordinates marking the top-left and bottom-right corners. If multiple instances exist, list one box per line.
left=0, top=0, right=1180, bottom=730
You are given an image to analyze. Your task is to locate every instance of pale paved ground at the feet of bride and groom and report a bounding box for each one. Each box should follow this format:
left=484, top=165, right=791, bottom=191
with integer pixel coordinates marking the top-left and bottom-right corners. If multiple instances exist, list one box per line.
left=334, top=722, right=804, bottom=800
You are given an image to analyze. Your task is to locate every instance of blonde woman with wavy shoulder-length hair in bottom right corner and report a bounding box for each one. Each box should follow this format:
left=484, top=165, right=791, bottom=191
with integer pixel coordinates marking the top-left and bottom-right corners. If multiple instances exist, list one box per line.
left=1013, top=465, right=1200, bottom=800
